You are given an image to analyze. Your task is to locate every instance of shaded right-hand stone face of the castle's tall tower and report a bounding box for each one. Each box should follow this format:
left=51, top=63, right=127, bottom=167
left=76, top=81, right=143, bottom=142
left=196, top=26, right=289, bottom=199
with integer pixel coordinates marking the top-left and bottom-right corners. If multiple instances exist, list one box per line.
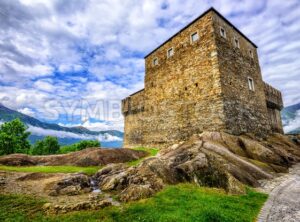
left=214, top=11, right=270, bottom=136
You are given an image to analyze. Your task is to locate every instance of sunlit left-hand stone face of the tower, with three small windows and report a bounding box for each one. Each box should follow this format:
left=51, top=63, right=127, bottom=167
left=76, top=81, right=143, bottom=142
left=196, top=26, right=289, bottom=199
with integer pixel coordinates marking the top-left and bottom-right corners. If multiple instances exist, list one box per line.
left=144, top=13, right=224, bottom=146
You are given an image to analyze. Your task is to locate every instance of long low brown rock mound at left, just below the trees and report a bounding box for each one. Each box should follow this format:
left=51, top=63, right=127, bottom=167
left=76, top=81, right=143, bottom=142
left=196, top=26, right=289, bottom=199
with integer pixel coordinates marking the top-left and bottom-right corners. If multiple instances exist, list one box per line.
left=0, top=148, right=148, bottom=166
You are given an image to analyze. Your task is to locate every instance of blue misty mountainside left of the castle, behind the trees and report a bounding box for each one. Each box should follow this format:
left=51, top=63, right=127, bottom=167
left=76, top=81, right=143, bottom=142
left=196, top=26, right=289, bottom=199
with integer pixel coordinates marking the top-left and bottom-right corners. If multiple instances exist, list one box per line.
left=0, top=104, right=124, bottom=147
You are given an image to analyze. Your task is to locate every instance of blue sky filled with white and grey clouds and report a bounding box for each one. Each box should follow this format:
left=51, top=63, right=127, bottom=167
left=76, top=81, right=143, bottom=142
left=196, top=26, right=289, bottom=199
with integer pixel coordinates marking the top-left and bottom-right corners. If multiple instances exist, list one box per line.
left=0, top=0, right=300, bottom=130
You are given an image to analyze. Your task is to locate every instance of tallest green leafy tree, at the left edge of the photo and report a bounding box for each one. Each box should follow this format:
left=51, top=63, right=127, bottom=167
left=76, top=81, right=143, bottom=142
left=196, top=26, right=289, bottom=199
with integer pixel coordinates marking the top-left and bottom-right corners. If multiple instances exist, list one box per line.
left=0, top=119, right=30, bottom=155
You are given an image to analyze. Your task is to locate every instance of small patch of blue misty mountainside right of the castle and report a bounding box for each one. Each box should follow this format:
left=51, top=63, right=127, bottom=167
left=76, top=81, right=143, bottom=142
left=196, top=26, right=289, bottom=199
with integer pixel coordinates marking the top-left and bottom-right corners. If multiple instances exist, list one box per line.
left=281, top=103, right=300, bottom=134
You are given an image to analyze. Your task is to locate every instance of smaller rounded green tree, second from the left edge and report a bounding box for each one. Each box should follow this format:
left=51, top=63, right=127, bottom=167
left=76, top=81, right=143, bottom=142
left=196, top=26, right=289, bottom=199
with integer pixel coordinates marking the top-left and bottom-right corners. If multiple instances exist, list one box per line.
left=32, top=136, right=60, bottom=155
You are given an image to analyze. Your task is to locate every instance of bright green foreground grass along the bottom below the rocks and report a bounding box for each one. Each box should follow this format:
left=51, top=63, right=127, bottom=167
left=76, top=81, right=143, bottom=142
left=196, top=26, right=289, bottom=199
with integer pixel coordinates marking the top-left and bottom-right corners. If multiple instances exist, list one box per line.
left=0, top=184, right=267, bottom=222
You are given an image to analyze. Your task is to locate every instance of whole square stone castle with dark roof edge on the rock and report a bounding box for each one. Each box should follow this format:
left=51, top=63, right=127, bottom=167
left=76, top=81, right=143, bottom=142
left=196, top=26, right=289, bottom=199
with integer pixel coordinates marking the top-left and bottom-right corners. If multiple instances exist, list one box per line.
left=122, top=8, right=283, bottom=147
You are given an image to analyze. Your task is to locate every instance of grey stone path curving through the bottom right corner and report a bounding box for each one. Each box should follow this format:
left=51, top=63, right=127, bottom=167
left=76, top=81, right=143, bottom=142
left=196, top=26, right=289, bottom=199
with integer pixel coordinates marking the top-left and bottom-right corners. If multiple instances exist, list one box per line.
left=258, top=164, right=300, bottom=222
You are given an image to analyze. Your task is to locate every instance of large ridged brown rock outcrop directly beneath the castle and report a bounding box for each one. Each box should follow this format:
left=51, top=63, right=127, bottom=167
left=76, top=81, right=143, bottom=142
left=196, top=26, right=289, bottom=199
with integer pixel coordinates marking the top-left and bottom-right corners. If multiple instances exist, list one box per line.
left=94, top=132, right=300, bottom=201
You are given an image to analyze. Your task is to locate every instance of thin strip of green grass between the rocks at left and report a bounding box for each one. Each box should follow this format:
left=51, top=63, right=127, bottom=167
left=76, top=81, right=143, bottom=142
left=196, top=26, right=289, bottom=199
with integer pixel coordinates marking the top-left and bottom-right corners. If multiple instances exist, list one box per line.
left=0, top=165, right=101, bottom=175
